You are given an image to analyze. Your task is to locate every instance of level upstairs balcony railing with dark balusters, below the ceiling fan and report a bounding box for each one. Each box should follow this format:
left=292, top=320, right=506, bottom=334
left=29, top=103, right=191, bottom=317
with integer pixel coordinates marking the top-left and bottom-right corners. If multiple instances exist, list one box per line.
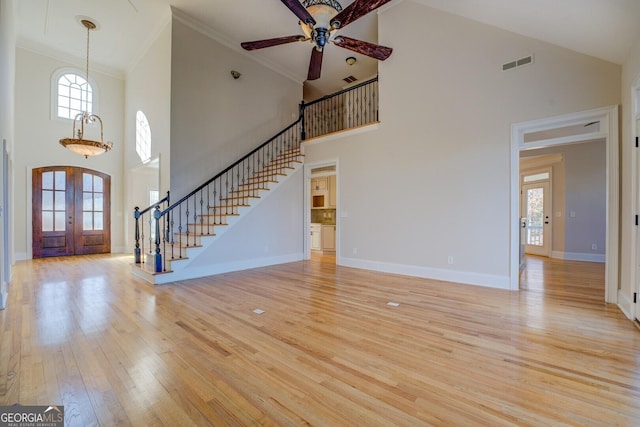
left=300, top=76, right=378, bottom=139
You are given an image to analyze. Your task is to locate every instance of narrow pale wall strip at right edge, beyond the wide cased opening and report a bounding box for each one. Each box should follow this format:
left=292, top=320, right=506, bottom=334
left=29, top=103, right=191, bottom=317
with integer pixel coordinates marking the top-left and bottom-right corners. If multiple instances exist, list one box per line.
left=618, top=36, right=640, bottom=317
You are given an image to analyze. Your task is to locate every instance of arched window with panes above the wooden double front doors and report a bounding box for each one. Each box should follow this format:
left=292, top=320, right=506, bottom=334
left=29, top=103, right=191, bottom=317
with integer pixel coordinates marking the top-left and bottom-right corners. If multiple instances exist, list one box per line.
left=54, top=71, right=94, bottom=120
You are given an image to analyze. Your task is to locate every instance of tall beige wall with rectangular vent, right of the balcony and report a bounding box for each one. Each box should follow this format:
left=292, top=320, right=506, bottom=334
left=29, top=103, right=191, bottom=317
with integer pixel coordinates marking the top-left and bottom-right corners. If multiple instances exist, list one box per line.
left=305, top=1, right=620, bottom=288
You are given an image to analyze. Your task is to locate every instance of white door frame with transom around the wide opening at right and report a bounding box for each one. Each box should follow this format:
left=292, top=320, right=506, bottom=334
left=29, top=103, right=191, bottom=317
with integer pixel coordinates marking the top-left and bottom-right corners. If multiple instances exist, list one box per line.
left=509, top=105, right=620, bottom=304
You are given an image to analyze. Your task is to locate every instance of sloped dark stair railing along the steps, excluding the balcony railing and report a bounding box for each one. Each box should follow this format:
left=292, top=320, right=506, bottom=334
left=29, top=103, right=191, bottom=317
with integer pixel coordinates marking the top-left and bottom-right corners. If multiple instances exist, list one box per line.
left=143, top=118, right=302, bottom=273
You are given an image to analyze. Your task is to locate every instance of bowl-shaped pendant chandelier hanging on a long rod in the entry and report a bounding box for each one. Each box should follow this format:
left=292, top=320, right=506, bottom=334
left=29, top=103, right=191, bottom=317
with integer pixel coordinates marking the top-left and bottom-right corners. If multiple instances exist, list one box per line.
left=60, top=19, right=113, bottom=158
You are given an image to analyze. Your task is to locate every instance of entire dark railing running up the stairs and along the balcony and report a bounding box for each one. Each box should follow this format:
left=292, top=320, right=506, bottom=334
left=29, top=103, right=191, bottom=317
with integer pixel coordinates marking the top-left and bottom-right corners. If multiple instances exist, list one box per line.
left=134, top=76, right=378, bottom=272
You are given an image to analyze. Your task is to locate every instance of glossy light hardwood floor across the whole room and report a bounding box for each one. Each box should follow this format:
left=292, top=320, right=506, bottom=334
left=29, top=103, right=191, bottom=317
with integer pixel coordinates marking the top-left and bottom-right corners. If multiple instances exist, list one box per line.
left=0, top=255, right=640, bottom=426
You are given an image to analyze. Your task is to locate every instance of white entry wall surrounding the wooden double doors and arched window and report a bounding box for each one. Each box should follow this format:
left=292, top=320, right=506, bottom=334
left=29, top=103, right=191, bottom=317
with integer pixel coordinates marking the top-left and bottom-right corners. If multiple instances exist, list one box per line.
left=14, top=46, right=125, bottom=259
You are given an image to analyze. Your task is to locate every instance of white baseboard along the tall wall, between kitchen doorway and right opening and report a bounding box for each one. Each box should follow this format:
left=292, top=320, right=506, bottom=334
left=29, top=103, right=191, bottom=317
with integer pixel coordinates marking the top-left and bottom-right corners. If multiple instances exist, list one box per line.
left=338, top=258, right=509, bottom=290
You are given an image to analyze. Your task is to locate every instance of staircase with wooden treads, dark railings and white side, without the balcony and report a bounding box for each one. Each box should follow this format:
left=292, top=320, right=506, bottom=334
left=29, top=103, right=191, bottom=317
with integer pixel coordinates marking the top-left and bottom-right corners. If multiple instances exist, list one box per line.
left=132, top=120, right=304, bottom=284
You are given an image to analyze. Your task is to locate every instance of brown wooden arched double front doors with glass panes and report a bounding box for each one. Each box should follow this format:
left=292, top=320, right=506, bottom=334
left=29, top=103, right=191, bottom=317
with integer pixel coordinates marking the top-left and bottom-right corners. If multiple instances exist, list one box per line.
left=32, top=166, right=111, bottom=258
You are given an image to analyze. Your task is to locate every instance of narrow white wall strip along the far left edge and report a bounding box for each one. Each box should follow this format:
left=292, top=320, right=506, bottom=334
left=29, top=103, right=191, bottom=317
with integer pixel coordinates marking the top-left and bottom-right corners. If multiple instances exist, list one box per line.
left=0, top=0, right=16, bottom=309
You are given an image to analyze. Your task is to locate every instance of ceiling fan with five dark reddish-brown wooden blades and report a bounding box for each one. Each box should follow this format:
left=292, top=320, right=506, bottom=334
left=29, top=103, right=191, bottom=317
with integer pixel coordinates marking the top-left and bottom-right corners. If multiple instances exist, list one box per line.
left=241, top=0, right=393, bottom=80
